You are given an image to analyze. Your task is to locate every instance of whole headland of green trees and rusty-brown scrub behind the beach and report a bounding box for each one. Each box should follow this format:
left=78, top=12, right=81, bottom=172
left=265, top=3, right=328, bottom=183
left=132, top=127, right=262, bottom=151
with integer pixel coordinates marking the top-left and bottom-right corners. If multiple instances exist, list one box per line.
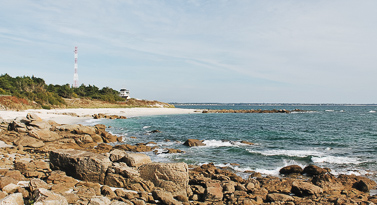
left=0, top=74, right=172, bottom=109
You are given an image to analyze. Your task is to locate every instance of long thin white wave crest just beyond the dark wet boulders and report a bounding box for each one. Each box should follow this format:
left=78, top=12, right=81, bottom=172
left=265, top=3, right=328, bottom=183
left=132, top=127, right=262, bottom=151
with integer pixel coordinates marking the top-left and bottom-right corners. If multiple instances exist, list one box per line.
left=247, top=149, right=324, bottom=157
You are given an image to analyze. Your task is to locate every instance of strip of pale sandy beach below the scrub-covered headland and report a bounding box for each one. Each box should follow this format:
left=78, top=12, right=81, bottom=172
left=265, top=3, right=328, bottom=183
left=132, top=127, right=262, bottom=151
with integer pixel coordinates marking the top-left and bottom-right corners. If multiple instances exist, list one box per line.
left=0, top=108, right=200, bottom=124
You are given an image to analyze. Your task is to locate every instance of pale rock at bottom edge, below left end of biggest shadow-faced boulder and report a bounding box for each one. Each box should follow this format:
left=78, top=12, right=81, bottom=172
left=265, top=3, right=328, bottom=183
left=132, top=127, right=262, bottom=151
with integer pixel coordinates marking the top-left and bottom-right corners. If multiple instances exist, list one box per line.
left=34, top=188, right=68, bottom=205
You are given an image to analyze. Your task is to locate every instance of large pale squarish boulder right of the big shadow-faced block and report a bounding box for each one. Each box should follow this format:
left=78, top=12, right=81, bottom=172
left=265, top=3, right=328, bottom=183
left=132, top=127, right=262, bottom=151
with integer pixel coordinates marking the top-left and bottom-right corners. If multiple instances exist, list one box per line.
left=139, top=163, right=189, bottom=196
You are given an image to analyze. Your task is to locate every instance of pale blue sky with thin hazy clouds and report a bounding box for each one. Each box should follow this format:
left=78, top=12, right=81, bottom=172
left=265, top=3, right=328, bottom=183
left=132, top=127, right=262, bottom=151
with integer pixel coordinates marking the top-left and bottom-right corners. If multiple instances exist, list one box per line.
left=0, top=0, right=377, bottom=103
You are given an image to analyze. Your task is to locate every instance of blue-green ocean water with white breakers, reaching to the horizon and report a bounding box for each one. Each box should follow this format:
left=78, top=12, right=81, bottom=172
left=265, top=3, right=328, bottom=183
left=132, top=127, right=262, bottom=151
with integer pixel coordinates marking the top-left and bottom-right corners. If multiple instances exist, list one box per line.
left=85, top=105, right=377, bottom=180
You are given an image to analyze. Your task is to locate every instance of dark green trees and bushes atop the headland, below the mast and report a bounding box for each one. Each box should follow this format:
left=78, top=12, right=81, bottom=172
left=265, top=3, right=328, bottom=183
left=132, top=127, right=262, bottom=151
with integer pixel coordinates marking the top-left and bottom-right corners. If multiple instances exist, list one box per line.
left=0, top=74, right=125, bottom=106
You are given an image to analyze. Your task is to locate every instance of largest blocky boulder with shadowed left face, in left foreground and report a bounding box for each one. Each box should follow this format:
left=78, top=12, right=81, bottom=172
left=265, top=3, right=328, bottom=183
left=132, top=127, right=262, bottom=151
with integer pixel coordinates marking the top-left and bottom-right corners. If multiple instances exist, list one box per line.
left=50, top=149, right=112, bottom=184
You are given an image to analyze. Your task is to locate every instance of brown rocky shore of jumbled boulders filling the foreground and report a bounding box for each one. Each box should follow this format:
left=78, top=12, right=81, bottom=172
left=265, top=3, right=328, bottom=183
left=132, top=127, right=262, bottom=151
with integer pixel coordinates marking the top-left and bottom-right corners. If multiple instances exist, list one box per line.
left=0, top=114, right=377, bottom=205
